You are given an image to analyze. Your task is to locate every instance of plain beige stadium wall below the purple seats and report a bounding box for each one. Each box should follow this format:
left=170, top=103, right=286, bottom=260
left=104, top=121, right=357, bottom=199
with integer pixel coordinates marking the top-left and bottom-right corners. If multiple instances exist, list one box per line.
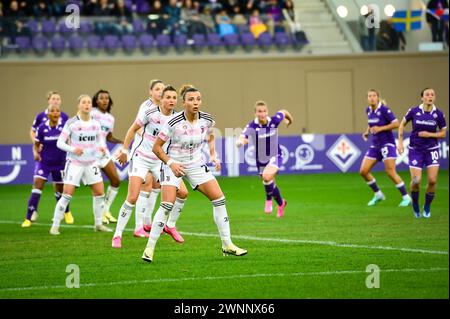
left=0, top=53, right=449, bottom=144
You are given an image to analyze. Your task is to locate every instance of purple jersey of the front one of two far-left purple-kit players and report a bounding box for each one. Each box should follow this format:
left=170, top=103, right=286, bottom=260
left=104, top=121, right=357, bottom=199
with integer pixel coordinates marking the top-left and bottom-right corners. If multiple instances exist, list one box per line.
left=36, top=118, right=66, bottom=166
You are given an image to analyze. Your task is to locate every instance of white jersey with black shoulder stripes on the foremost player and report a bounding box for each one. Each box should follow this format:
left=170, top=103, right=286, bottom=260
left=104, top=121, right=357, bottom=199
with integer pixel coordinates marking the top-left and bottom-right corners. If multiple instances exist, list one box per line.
left=158, top=111, right=215, bottom=168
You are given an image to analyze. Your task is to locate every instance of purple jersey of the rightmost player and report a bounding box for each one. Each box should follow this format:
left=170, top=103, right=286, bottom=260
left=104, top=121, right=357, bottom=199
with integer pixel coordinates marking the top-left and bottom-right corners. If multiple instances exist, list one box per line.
left=405, top=104, right=447, bottom=150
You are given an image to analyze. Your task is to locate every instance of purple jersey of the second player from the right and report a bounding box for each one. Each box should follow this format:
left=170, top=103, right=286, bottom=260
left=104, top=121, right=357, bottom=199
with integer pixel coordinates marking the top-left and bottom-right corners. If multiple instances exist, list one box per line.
left=366, top=103, right=397, bottom=148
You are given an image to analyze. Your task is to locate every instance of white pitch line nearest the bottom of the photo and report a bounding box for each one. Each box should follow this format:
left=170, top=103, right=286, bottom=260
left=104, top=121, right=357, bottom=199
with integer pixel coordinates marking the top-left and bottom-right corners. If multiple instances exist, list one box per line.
left=0, top=268, right=448, bottom=292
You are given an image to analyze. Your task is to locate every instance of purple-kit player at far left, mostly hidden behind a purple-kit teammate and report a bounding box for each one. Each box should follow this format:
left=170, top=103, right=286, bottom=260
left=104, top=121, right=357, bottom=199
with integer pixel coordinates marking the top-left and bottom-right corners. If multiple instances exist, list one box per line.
left=24, top=91, right=74, bottom=227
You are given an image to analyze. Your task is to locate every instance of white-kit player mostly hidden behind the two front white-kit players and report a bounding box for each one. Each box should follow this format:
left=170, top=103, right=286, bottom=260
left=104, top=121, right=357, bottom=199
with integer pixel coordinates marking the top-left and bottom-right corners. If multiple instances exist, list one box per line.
left=130, top=79, right=165, bottom=237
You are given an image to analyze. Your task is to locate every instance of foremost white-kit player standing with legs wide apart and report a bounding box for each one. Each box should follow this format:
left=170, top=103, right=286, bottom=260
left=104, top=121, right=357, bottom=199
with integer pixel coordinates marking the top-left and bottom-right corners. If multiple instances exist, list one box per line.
left=142, top=87, right=247, bottom=262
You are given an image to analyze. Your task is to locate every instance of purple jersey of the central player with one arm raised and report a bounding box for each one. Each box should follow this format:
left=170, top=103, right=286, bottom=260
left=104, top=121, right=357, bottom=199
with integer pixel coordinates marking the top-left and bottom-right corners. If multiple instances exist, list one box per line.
left=242, top=112, right=284, bottom=165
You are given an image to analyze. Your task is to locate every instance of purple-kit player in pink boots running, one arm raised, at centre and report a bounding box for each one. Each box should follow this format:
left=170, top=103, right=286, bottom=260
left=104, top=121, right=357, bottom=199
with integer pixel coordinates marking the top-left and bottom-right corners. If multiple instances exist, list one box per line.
left=236, top=101, right=293, bottom=217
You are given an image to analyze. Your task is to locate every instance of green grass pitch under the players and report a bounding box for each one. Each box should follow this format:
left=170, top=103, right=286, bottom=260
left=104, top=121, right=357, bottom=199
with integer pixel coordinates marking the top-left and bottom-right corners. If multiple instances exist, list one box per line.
left=0, top=171, right=449, bottom=299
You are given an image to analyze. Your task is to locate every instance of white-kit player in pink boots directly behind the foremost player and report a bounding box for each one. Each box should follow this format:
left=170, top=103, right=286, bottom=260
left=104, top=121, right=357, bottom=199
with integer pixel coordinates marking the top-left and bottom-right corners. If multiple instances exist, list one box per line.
left=112, top=86, right=188, bottom=248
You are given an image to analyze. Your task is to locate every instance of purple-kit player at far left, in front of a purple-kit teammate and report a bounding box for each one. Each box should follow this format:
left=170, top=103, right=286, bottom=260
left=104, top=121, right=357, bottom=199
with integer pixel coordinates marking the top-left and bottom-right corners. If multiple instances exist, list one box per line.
left=22, top=104, right=66, bottom=227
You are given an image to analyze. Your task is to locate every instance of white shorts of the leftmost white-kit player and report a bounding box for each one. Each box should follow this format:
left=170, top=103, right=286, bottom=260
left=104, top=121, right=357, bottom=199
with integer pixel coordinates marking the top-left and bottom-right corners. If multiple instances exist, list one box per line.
left=63, top=161, right=103, bottom=187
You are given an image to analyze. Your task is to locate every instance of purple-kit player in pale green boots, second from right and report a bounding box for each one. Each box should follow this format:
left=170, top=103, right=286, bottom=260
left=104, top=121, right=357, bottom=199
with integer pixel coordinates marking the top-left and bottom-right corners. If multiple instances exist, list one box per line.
left=359, top=89, right=411, bottom=207
